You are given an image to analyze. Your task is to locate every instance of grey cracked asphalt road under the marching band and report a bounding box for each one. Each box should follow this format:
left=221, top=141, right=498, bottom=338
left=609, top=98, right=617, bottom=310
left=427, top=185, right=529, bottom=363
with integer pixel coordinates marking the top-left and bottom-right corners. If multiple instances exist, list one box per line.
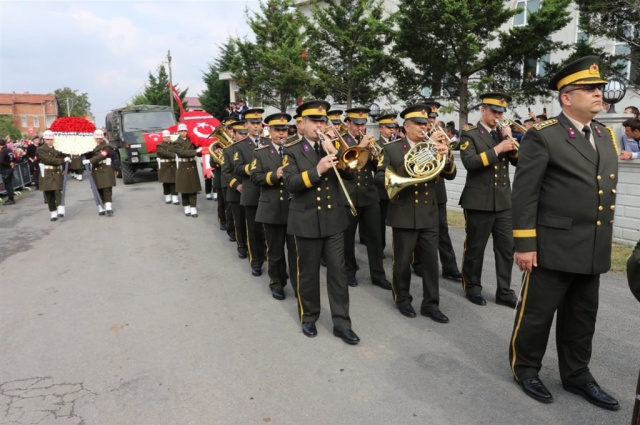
left=0, top=174, right=640, bottom=425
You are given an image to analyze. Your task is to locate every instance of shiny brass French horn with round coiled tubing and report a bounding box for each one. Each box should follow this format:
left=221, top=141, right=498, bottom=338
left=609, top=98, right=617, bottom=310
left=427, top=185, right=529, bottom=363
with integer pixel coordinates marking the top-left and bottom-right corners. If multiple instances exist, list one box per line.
left=384, top=132, right=451, bottom=199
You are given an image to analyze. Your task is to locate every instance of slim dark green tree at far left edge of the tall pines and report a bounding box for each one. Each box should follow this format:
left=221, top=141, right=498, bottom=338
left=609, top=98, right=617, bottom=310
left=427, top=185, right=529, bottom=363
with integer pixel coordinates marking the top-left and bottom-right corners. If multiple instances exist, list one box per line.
left=199, top=39, right=238, bottom=119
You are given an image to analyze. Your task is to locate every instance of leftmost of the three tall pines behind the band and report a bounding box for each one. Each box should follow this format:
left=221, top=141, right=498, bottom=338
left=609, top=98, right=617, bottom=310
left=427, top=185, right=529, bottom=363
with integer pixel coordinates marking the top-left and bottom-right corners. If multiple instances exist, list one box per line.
left=230, top=0, right=312, bottom=112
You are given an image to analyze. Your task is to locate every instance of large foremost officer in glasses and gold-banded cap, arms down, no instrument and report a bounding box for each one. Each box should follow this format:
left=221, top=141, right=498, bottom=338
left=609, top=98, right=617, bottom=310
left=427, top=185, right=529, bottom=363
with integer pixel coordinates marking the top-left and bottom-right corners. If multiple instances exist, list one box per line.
left=509, top=56, right=620, bottom=410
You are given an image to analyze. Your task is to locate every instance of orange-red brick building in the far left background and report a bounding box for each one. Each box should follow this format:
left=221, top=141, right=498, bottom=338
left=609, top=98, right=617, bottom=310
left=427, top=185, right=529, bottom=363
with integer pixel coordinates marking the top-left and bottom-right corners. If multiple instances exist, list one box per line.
left=0, top=93, right=58, bottom=134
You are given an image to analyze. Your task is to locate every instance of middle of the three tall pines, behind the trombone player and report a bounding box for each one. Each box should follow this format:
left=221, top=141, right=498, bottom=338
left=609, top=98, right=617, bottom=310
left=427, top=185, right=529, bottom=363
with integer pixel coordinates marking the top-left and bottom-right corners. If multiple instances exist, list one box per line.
left=307, top=0, right=395, bottom=108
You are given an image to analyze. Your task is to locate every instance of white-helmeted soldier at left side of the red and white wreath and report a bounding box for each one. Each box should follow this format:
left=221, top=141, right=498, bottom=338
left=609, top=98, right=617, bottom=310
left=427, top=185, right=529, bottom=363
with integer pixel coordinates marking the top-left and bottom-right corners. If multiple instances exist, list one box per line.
left=36, top=130, right=69, bottom=221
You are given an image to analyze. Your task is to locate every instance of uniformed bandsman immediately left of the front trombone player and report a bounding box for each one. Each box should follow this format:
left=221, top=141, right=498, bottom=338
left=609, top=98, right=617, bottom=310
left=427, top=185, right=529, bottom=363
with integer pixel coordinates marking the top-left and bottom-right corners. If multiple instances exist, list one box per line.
left=251, top=113, right=296, bottom=300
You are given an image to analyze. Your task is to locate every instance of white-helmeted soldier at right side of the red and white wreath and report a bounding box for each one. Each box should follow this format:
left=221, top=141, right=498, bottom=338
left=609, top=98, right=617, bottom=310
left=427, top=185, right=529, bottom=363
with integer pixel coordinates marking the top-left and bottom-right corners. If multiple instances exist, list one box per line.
left=82, top=130, right=116, bottom=216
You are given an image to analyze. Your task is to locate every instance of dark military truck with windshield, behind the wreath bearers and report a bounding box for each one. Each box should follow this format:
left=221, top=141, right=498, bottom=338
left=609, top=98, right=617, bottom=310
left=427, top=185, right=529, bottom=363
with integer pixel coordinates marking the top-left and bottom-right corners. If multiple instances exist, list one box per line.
left=105, top=105, right=176, bottom=184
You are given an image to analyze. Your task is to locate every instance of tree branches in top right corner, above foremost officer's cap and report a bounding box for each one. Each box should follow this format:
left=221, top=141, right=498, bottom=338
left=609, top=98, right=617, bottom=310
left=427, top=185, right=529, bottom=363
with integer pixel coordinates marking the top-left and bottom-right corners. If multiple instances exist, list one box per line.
left=576, top=0, right=640, bottom=85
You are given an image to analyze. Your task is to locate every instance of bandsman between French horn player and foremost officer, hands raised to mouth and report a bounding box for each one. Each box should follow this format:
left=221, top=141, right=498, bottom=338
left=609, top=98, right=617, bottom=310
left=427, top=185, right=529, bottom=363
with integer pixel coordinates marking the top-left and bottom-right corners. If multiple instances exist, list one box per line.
left=460, top=93, right=518, bottom=308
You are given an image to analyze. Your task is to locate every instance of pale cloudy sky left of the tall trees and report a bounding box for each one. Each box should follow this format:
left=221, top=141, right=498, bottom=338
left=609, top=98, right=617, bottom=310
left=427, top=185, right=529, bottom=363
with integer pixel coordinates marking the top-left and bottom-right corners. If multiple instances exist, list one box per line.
left=0, top=0, right=259, bottom=127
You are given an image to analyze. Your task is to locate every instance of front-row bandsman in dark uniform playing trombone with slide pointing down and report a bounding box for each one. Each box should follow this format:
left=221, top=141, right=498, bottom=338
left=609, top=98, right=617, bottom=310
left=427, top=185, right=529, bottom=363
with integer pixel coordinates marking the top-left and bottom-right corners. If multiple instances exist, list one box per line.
left=283, top=100, right=360, bottom=344
